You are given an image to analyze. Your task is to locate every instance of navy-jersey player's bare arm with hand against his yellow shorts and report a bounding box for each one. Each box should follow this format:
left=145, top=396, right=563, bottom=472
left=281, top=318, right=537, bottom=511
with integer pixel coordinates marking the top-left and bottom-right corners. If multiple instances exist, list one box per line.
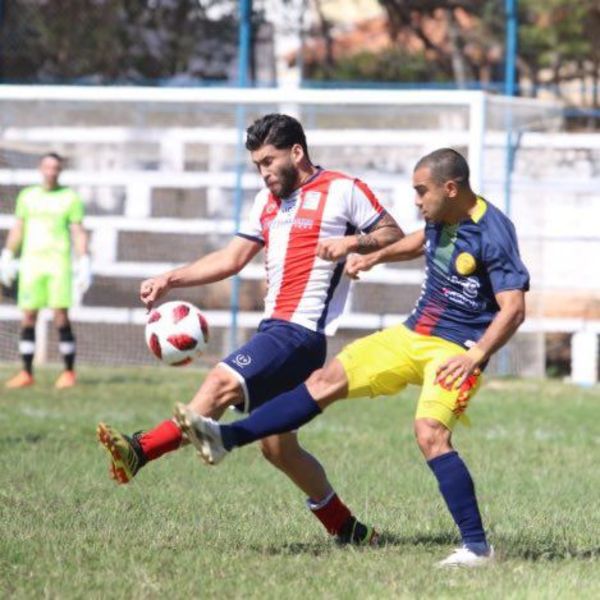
left=436, top=290, right=525, bottom=387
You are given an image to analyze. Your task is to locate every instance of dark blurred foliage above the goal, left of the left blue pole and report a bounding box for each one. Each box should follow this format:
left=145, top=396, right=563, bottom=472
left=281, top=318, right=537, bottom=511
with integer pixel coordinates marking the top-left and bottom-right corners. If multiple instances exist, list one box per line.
left=1, top=0, right=237, bottom=83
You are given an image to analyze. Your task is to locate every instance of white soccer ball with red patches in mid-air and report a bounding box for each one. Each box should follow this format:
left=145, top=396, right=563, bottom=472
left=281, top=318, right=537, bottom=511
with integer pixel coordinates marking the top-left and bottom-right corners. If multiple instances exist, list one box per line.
left=145, top=300, right=208, bottom=367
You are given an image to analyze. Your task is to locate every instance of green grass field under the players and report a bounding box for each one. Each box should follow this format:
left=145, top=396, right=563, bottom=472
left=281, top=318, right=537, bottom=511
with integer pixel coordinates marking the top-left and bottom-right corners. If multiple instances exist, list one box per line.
left=0, top=368, right=600, bottom=598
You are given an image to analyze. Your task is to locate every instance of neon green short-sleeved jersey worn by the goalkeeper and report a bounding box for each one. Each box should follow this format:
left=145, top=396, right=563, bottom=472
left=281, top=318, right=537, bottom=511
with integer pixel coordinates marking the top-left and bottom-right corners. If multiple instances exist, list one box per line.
left=15, top=185, right=83, bottom=262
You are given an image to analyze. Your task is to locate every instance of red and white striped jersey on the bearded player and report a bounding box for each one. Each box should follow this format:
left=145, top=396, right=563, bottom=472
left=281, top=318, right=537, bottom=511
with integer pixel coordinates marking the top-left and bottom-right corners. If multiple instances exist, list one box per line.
left=238, top=170, right=384, bottom=335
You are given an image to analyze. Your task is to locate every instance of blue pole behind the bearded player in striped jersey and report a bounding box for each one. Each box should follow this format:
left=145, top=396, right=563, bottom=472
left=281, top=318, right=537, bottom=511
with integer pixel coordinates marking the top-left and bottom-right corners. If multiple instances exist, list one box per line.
left=229, top=0, right=252, bottom=352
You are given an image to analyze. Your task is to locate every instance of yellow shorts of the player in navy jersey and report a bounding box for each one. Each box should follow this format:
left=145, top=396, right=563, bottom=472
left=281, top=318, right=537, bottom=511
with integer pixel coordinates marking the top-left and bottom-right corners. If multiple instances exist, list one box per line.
left=337, top=325, right=482, bottom=430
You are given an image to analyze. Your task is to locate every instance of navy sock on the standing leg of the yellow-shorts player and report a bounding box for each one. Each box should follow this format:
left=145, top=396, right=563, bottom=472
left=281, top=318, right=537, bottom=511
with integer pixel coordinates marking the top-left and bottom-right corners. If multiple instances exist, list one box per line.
left=427, top=451, right=488, bottom=554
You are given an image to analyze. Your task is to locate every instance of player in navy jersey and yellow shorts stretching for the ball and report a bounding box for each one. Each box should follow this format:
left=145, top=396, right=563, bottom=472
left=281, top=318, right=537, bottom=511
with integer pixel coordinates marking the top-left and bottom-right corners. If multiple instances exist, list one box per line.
left=176, top=148, right=529, bottom=566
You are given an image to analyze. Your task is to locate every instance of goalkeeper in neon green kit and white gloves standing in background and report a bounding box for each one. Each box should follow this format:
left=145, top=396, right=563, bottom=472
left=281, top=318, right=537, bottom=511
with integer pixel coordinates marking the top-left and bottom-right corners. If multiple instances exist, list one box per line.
left=0, top=152, right=91, bottom=389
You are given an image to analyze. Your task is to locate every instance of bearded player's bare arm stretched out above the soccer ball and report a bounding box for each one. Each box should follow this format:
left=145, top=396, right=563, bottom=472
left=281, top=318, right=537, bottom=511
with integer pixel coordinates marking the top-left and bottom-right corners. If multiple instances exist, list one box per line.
left=140, top=236, right=262, bottom=310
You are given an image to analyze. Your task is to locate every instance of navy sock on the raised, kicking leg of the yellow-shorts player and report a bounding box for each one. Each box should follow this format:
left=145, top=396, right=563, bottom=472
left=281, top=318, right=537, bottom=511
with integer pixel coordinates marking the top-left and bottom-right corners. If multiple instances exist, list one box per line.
left=221, top=383, right=321, bottom=450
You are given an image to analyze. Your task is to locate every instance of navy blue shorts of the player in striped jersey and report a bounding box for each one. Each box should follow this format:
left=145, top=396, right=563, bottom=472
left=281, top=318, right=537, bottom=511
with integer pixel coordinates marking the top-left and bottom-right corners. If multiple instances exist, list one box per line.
left=219, top=319, right=327, bottom=412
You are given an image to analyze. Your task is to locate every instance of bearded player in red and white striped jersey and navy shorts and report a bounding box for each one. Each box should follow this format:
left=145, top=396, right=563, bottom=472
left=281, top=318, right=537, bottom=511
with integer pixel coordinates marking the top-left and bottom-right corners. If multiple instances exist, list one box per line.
left=97, top=114, right=403, bottom=544
